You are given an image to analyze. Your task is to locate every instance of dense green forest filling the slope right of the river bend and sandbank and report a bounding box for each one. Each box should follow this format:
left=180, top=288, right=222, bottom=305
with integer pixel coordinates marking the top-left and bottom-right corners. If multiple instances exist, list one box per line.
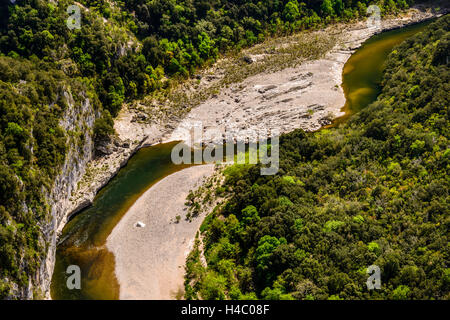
left=185, top=15, right=450, bottom=299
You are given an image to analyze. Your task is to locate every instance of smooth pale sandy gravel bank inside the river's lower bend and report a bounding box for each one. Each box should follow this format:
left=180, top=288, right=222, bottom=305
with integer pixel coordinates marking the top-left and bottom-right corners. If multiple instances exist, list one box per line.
left=106, top=164, right=214, bottom=299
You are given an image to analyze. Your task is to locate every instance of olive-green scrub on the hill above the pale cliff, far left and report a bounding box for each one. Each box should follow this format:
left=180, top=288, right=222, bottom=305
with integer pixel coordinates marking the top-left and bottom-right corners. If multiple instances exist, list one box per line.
left=0, top=56, right=95, bottom=296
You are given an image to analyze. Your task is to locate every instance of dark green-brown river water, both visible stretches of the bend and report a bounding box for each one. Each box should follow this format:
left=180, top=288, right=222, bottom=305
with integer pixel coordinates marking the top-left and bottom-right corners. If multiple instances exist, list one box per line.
left=51, top=23, right=427, bottom=299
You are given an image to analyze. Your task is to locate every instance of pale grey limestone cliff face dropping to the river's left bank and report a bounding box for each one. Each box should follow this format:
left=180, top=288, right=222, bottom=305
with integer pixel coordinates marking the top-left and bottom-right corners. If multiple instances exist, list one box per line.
left=18, top=89, right=146, bottom=299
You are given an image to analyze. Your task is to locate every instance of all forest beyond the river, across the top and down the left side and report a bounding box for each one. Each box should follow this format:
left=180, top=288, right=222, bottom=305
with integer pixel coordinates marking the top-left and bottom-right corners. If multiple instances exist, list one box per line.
left=0, top=0, right=426, bottom=297
